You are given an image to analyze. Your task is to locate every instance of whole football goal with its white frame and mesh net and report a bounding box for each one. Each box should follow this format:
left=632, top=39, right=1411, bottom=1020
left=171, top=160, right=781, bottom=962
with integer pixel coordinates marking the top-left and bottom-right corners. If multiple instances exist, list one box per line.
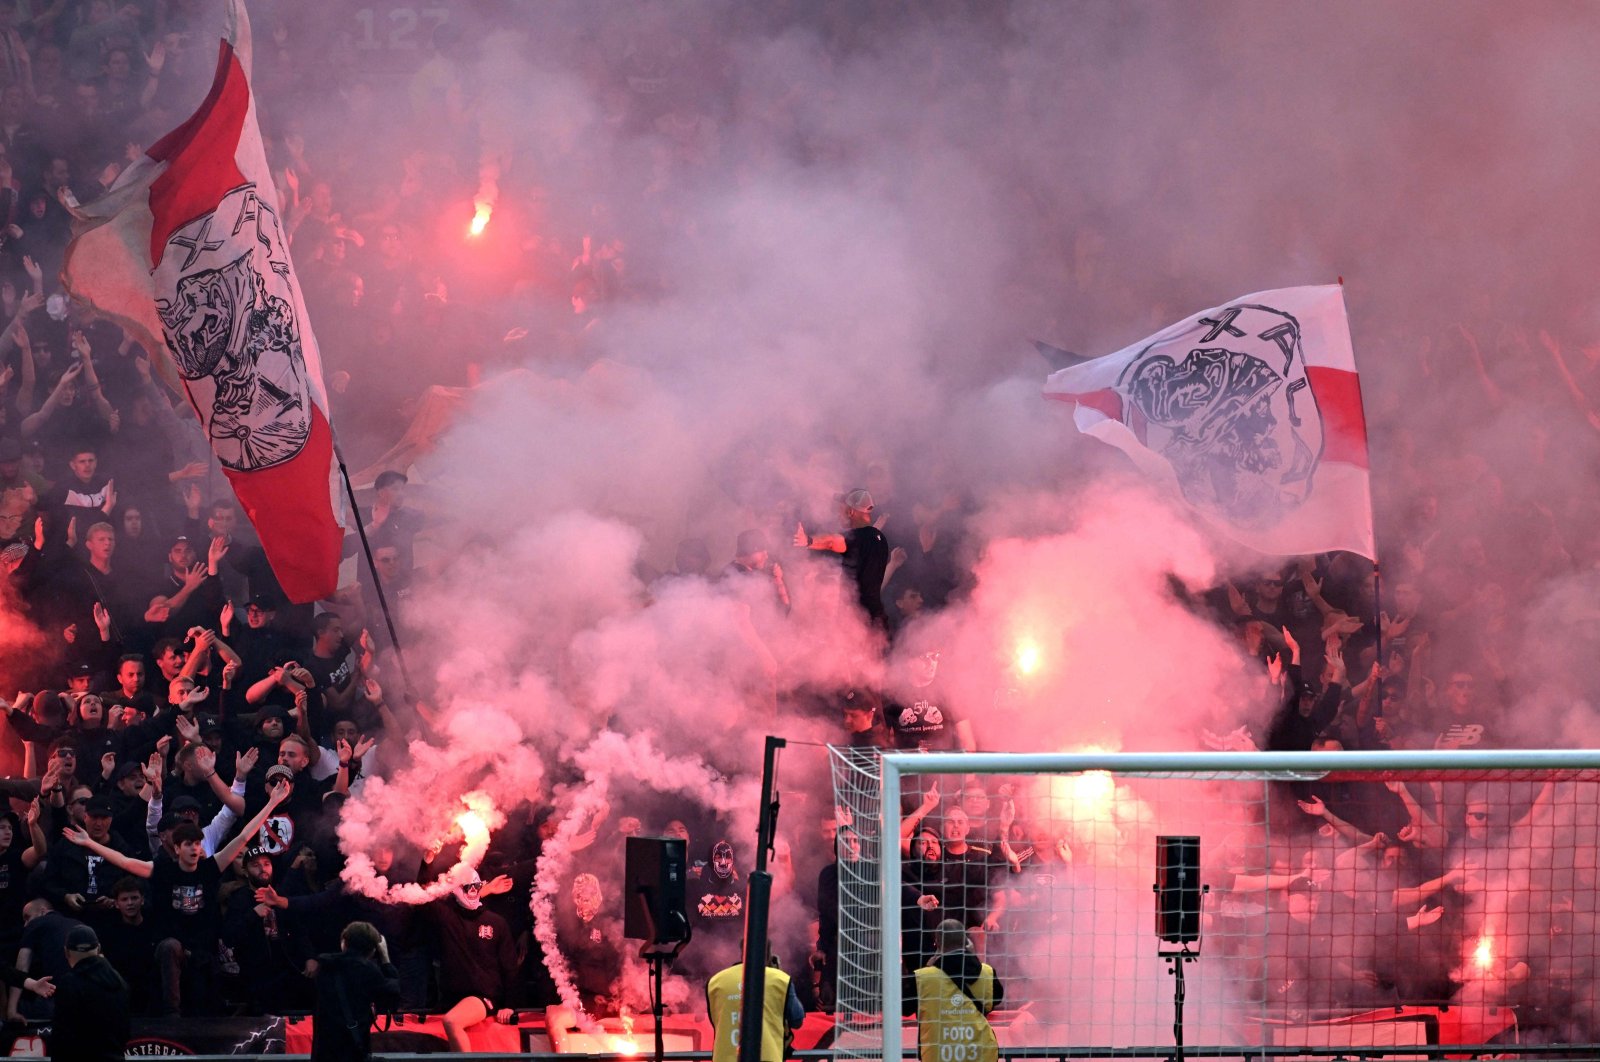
left=822, top=749, right=1600, bottom=1062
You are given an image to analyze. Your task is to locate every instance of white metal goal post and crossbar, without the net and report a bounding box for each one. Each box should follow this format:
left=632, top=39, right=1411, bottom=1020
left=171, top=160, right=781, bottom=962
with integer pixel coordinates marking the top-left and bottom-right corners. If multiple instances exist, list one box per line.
left=878, top=749, right=1600, bottom=1059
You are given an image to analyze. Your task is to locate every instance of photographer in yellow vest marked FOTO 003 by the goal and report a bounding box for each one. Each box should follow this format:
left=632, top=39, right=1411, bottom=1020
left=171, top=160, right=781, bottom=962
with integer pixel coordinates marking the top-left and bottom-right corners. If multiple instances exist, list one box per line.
left=902, top=918, right=1005, bottom=1062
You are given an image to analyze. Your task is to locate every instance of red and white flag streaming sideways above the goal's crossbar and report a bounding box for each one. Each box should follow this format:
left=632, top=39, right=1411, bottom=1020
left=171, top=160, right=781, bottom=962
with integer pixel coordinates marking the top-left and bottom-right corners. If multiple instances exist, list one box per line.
left=1045, top=285, right=1378, bottom=560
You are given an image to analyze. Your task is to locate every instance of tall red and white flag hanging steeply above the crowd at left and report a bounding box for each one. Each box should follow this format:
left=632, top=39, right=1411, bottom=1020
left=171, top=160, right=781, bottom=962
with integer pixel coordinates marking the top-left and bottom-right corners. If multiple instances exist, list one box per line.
left=62, top=0, right=347, bottom=603
